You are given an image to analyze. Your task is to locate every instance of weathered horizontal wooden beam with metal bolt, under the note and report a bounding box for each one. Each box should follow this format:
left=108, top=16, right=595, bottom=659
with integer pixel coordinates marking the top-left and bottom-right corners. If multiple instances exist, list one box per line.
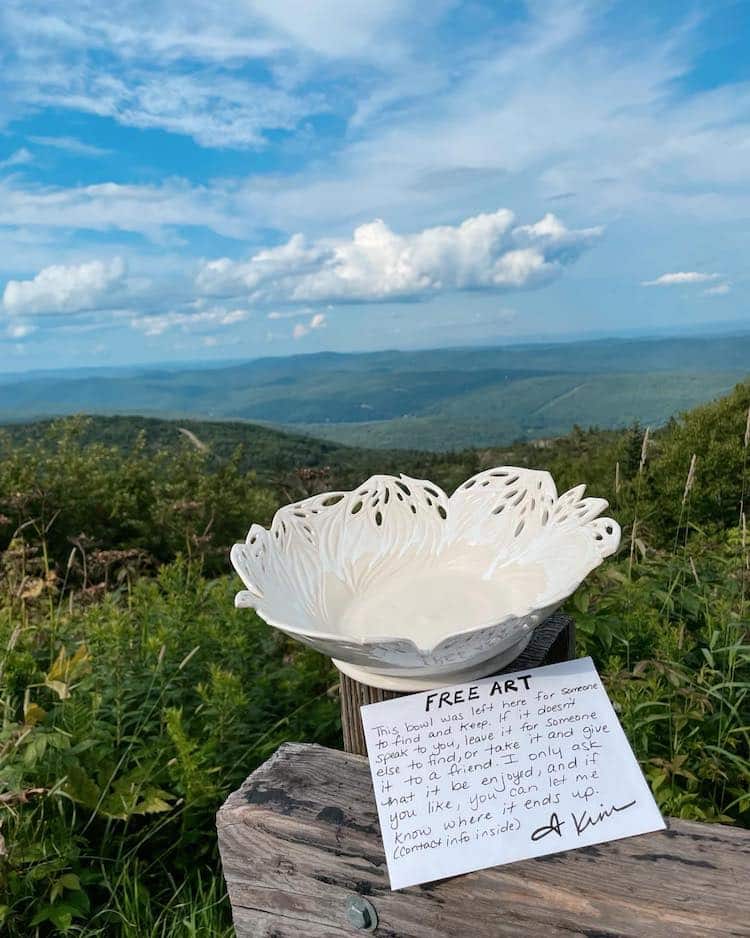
left=217, top=743, right=750, bottom=938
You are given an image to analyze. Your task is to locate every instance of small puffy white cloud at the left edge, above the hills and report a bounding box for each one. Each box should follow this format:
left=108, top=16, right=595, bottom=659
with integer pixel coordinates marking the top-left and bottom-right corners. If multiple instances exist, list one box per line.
left=3, top=257, right=125, bottom=316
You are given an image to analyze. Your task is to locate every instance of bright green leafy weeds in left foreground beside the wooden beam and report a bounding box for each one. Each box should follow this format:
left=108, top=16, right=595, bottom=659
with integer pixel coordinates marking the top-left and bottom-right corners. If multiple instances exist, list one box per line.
left=0, top=562, right=339, bottom=936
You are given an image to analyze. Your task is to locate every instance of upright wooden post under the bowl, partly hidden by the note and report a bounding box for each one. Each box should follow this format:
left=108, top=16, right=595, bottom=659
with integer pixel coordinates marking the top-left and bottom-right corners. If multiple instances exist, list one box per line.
left=340, top=613, right=576, bottom=756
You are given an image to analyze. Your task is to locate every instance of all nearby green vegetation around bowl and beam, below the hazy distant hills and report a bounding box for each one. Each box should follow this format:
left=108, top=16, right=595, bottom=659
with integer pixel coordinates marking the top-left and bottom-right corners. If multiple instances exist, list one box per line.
left=0, top=384, right=750, bottom=938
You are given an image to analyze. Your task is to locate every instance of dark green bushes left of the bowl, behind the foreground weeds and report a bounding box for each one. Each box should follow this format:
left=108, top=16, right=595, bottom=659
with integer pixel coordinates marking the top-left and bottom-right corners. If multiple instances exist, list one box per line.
left=0, top=418, right=278, bottom=585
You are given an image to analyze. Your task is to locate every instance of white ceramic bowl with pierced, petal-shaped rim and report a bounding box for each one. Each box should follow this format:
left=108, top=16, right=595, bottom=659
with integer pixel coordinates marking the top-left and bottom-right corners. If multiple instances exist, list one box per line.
left=231, top=466, right=620, bottom=690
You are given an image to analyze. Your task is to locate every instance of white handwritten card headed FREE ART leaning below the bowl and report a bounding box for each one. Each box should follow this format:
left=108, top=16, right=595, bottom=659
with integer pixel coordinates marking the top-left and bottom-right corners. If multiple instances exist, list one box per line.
left=362, top=658, right=665, bottom=889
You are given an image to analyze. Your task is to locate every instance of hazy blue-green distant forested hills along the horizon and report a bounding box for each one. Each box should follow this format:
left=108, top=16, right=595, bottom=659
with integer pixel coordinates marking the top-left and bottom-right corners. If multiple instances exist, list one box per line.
left=0, top=335, right=750, bottom=451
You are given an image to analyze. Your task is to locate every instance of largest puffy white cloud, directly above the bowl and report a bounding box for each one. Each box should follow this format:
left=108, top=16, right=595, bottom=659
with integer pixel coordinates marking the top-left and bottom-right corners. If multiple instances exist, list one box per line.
left=197, top=209, right=602, bottom=303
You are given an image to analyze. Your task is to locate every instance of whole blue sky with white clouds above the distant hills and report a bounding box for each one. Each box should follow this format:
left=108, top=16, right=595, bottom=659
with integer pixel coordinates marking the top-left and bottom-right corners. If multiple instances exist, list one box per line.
left=0, top=0, right=750, bottom=371
